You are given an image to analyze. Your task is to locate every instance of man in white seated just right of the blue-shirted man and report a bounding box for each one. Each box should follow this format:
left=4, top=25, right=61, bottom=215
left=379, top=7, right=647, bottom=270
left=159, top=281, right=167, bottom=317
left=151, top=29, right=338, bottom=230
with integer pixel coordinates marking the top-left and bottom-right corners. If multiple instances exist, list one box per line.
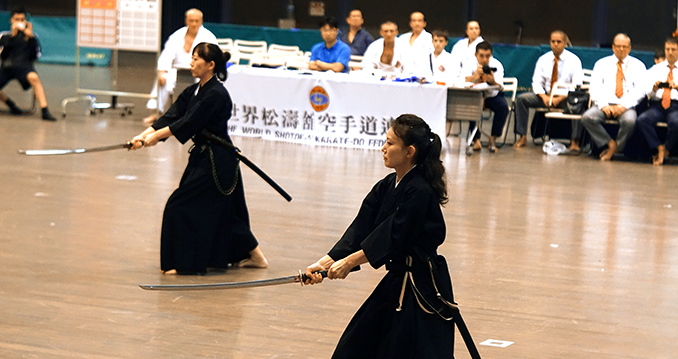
left=360, top=21, right=403, bottom=73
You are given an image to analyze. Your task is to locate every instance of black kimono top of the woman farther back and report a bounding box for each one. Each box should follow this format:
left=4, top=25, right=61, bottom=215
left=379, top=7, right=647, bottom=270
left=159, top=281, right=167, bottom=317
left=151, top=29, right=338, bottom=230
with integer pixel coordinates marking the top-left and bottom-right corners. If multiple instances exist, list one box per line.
left=151, top=76, right=233, bottom=144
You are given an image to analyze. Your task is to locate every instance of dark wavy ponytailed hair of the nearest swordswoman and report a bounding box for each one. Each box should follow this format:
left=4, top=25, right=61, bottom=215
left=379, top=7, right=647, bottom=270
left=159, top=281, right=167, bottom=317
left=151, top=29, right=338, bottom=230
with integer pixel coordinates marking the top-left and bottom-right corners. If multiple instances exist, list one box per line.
left=391, top=114, right=449, bottom=205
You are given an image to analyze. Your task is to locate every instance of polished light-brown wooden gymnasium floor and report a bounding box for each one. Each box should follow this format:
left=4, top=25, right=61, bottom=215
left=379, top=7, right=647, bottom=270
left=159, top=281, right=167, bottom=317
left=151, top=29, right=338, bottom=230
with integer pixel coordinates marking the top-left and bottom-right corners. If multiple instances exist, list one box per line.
left=0, top=60, right=678, bottom=359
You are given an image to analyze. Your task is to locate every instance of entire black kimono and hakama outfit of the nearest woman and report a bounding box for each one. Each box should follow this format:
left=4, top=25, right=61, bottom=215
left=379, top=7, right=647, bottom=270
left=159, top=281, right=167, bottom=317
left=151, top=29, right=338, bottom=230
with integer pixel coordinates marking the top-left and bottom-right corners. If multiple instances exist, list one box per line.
left=328, top=167, right=454, bottom=359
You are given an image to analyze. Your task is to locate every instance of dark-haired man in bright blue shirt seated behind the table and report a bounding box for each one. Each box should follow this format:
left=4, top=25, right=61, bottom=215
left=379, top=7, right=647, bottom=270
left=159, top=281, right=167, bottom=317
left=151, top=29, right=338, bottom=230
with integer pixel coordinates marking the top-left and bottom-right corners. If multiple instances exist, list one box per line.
left=308, top=16, right=351, bottom=72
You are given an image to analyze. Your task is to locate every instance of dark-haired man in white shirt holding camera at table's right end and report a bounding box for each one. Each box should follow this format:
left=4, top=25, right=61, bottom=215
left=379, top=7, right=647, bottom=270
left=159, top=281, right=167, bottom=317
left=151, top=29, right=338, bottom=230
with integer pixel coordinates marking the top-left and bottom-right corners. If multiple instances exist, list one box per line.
left=459, top=41, right=509, bottom=153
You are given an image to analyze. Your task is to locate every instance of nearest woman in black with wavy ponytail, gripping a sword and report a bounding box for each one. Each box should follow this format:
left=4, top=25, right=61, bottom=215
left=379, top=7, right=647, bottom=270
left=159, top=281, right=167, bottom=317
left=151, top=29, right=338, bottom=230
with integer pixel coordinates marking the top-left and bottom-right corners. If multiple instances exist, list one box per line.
left=306, top=115, right=462, bottom=359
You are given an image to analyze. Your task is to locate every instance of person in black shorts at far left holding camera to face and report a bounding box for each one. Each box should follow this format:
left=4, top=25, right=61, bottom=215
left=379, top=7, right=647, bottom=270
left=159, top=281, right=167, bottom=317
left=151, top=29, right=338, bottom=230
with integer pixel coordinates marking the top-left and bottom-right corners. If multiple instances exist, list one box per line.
left=0, top=8, right=56, bottom=121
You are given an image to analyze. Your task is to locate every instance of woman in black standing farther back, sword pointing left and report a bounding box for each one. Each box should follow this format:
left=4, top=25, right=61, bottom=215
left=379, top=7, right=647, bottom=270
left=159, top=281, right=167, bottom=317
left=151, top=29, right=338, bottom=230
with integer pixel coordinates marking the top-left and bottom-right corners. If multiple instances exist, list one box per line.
left=131, top=42, right=268, bottom=274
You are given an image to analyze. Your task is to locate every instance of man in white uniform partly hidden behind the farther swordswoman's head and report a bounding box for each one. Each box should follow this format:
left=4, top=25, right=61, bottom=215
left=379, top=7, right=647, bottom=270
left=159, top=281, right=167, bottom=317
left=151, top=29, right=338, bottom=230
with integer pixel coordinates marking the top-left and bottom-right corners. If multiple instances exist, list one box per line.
left=143, top=9, right=217, bottom=124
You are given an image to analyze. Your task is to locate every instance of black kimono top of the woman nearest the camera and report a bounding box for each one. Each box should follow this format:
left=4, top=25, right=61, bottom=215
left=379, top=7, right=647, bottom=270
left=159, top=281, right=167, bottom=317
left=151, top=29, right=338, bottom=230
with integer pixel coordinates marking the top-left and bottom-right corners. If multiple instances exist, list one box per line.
left=328, top=166, right=446, bottom=269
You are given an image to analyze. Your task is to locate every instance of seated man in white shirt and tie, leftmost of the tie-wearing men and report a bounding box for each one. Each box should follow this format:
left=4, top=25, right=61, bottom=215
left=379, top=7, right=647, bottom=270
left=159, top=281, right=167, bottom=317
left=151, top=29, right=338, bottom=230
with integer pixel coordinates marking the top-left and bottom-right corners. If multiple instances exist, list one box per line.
left=513, top=30, right=584, bottom=151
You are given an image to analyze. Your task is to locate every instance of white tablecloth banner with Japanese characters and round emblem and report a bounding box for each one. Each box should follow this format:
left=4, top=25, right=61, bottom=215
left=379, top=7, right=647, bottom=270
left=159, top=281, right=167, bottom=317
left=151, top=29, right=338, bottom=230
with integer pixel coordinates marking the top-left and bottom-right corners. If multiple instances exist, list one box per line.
left=225, top=66, right=454, bottom=149
